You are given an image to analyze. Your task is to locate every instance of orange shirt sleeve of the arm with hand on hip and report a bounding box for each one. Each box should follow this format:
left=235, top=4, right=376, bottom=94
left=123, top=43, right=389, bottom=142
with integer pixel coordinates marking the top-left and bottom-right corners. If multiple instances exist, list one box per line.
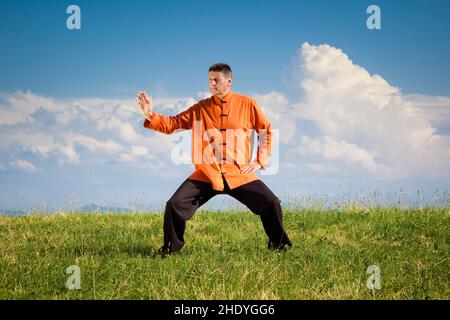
left=251, top=99, right=272, bottom=169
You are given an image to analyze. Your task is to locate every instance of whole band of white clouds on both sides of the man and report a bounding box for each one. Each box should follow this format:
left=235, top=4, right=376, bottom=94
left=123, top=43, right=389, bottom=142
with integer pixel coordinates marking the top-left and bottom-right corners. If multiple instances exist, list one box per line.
left=0, top=43, right=450, bottom=184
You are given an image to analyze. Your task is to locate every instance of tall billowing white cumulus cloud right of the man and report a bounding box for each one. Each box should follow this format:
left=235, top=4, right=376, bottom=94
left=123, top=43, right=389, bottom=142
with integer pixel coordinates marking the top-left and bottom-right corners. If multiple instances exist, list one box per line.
left=291, top=43, right=450, bottom=179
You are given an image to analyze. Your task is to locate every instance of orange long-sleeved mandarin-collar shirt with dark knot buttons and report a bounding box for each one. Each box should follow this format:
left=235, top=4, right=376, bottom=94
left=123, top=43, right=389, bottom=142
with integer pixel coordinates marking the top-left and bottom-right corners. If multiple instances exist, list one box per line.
left=144, top=92, right=272, bottom=191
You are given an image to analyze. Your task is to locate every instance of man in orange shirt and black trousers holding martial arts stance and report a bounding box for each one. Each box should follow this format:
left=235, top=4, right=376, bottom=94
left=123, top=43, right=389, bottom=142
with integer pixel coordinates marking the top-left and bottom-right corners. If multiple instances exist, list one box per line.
left=136, top=63, right=292, bottom=255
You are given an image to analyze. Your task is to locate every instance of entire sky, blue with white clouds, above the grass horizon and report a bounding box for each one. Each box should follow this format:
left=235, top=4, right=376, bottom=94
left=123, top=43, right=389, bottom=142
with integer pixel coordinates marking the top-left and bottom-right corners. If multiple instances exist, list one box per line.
left=0, top=0, right=450, bottom=212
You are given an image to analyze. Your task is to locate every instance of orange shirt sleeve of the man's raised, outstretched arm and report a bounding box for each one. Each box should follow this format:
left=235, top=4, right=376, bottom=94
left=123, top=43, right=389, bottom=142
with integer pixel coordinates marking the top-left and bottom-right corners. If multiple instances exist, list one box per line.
left=144, top=104, right=198, bottom=134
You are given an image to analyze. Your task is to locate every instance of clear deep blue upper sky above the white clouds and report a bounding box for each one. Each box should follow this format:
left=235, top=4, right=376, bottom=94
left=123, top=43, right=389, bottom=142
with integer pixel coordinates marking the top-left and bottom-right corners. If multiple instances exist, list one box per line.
left=0, top=0, right=450, bottom=97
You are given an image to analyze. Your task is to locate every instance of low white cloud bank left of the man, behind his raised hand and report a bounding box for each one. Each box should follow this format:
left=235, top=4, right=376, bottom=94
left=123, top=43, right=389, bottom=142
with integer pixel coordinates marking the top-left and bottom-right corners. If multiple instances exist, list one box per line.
left=0, top=91, right=200, bottom=176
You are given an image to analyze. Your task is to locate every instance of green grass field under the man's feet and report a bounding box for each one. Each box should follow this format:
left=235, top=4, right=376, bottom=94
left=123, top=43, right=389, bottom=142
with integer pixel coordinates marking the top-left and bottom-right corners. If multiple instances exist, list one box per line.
left=0, top=208, right=450, bottom=299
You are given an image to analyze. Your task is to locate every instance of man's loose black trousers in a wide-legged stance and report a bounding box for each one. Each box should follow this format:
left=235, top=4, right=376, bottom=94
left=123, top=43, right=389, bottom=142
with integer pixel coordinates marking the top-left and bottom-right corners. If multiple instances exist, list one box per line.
left=162, top=179, right=292, bottom=252
